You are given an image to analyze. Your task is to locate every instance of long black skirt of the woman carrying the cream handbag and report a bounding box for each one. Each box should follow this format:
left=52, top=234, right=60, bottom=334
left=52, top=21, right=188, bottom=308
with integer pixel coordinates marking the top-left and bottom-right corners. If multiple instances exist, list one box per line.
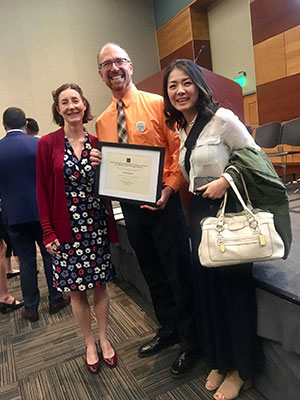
left=190, top=195, right=257, bottom=381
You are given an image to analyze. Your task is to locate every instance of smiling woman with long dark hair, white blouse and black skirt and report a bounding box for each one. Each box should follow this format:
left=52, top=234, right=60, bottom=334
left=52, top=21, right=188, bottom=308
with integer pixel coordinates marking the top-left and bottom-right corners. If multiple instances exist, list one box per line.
left=164, top=59, right=259, bottom=400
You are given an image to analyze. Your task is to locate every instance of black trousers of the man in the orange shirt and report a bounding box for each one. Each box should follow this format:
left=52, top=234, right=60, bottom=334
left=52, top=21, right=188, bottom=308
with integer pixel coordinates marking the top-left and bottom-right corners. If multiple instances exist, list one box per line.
left=121, top=194, right=196, bottom=350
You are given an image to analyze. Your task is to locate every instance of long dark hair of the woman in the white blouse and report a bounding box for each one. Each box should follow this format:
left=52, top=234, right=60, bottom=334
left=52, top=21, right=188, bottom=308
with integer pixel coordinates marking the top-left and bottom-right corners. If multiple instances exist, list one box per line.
left=163, top=59, right=218, bottom=130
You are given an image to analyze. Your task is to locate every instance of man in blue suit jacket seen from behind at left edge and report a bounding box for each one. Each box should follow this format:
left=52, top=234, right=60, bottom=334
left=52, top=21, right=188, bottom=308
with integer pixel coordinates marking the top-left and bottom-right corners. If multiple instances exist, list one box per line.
left=0, top=107, right=70, bottom=322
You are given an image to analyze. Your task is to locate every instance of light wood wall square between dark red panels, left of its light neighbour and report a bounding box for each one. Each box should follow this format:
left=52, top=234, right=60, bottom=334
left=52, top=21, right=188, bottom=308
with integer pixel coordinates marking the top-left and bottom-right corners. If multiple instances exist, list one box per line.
left=254, top=33, right=286, bottom=85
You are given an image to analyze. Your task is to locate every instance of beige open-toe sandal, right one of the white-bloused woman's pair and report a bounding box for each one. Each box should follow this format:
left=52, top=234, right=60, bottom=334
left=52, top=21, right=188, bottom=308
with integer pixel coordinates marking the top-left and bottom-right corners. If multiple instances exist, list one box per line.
left=214, top=370, right=251, bottom=400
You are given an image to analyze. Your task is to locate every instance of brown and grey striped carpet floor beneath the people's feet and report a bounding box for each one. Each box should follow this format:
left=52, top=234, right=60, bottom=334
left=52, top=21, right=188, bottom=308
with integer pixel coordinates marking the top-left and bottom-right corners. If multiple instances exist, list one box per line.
left=0, top=255, right=264, bottom=400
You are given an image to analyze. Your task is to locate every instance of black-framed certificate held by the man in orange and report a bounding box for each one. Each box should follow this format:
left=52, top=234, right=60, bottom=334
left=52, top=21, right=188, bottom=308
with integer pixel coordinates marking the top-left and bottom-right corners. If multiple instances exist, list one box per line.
left=95, top=142, right=165, bottom=205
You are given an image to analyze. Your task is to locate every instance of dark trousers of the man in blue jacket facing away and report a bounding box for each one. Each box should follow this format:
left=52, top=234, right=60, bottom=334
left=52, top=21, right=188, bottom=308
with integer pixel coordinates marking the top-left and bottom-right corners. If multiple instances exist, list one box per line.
left=8, top=221, right=62, bottom=312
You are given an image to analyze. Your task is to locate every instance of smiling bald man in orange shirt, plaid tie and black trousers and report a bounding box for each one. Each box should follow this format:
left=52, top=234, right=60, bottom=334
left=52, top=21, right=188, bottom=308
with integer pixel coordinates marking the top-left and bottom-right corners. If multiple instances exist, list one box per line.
left=92, top=43, right=196, bottom=377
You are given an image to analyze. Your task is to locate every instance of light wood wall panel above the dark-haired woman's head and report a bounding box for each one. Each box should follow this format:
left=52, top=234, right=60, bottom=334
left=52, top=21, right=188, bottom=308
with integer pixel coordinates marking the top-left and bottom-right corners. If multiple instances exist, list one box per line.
left=157, top=8, right=193, bottom=59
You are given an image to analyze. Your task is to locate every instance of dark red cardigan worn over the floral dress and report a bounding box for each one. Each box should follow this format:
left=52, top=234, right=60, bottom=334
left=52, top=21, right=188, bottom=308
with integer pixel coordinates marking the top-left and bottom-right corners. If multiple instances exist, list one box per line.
left=36, top=128, right=117, bottom=245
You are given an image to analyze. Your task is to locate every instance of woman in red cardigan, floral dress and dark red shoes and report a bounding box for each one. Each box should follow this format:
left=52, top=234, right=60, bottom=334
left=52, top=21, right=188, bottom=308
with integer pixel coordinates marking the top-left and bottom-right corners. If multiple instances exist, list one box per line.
left=37, top=83, right=117, bottom=374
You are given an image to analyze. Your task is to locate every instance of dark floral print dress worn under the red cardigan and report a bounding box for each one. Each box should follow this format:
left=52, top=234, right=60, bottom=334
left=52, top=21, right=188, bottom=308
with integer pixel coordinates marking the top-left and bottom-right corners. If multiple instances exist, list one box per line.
left=53, top=134, right=113, bottom=292
